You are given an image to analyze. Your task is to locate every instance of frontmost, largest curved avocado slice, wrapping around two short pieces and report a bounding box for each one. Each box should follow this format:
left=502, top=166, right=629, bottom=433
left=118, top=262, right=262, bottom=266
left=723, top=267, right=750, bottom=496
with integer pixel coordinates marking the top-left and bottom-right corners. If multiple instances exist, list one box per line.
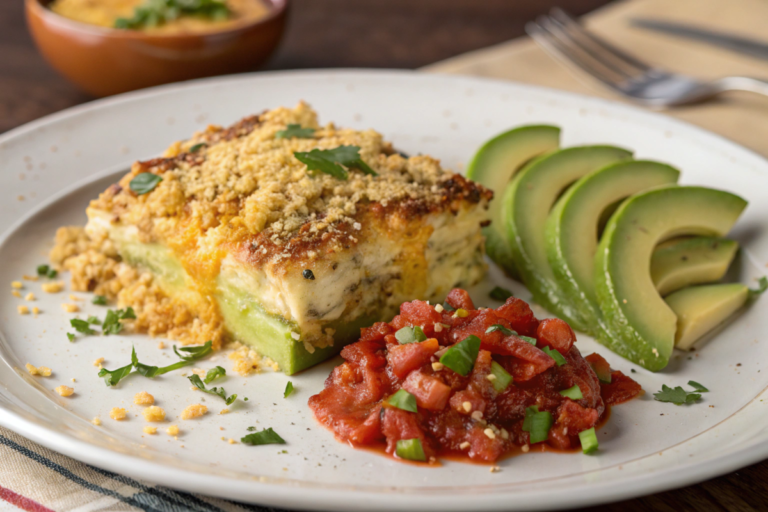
left=595, top=186, right=747, bottom=371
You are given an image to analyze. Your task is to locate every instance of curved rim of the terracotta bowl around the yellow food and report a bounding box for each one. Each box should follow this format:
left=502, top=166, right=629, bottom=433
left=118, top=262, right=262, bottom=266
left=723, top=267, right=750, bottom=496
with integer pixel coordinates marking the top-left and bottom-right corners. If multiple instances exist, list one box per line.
left=25, top=0, right=290, bottom=40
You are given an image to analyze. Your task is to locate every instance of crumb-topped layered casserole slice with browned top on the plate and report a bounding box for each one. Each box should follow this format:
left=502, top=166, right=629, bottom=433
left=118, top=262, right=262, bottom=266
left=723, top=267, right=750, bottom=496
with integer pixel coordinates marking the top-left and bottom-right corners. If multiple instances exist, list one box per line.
left=51, top=103, right=493, bottom=374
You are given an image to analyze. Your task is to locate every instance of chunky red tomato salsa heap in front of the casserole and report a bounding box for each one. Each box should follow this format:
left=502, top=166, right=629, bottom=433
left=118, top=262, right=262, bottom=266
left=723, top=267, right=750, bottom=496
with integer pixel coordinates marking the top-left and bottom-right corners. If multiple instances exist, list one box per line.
left=309, top=288, right=642, bottom=463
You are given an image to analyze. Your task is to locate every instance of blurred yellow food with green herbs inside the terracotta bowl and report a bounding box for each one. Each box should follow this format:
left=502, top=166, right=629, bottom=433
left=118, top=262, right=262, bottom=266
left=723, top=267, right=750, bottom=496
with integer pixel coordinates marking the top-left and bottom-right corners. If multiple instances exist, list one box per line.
left=49, top=0, right=270, bottom=34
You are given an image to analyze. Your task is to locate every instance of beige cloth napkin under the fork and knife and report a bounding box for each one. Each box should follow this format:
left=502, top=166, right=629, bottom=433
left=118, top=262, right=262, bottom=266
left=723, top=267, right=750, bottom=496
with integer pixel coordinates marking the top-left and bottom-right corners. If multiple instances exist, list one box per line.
left=423, top=0, right=768, bottom=156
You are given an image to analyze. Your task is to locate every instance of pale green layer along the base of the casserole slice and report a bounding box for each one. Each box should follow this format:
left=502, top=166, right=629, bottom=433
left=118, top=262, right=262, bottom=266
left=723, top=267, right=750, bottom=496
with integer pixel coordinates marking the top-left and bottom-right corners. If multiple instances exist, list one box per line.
left=112, top=239, right=372, bottom=375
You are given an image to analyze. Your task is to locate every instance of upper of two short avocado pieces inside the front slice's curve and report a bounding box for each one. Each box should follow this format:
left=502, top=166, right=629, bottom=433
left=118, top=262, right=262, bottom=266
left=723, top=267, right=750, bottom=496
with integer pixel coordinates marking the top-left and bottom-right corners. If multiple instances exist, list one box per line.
left=651, top=236, right=739, bottom=297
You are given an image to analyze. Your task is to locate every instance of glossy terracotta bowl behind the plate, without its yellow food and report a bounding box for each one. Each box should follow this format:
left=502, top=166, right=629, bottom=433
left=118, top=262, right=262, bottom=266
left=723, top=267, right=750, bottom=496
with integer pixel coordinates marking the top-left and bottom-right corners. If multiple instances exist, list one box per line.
left=25, top=0, right=288, bottom=96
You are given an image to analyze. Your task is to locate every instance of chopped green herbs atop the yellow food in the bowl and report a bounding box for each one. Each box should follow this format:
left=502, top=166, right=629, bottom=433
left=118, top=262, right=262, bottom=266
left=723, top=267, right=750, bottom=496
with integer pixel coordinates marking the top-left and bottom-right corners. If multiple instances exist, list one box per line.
left=115, top=0, right=230, bottom=29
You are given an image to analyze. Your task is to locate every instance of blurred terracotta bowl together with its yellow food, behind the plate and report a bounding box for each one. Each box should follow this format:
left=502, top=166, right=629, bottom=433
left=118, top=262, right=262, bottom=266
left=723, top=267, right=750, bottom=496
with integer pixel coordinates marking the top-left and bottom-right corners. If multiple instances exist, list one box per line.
left=25, top=0, right=288, bottom=96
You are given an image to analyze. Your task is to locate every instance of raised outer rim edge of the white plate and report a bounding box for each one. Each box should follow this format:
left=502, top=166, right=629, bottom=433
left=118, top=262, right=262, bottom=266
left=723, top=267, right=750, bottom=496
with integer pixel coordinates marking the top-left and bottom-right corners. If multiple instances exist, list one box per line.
left=0, top=69, right=768, bottom=510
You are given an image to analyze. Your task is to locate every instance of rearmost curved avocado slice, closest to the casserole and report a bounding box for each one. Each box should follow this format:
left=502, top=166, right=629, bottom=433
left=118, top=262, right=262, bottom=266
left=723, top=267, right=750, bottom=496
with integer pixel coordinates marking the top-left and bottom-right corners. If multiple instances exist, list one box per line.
left=467, top=125, right=560, bottom=279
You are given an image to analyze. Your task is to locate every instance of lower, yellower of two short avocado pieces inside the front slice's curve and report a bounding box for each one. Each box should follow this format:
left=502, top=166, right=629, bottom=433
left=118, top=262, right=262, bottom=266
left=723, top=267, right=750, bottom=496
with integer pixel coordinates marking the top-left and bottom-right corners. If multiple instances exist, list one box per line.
left=664, top=283, right=749, bottom=350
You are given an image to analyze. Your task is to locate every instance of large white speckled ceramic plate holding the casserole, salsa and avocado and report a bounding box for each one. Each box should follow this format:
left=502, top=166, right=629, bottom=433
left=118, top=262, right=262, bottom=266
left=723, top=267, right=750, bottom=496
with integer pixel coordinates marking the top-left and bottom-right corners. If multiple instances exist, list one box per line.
left=0, top=71, right=768, bottom=511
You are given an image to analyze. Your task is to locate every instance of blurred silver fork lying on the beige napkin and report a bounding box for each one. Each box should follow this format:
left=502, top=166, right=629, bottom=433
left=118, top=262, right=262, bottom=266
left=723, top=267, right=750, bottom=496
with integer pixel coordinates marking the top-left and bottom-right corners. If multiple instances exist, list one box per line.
left=525, top=8, right=768, bottom=107
